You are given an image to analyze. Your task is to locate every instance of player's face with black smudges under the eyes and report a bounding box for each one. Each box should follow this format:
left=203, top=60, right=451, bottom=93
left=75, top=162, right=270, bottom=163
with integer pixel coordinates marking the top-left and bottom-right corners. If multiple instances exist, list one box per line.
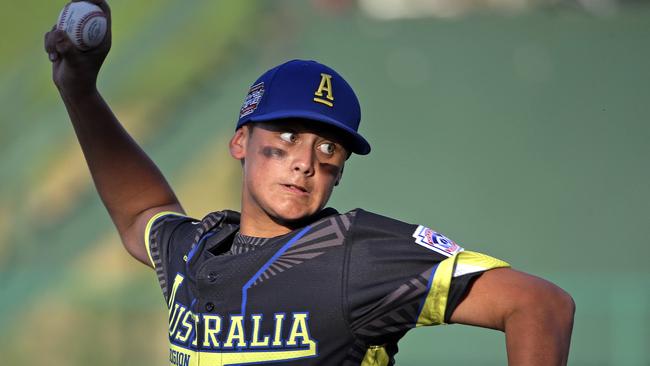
left=230, top=120, right=348, bottom=234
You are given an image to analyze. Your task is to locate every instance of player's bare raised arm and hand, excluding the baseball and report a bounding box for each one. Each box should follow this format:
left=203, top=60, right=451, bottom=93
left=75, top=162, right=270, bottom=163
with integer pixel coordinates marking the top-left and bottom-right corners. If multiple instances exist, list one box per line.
left=45, top=0, right=183, bottom=266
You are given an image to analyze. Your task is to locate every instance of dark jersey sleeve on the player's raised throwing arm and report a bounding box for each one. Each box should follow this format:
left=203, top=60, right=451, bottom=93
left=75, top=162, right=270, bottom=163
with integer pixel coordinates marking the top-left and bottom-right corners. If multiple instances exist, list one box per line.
left=144, top=211, right=198, bottom=301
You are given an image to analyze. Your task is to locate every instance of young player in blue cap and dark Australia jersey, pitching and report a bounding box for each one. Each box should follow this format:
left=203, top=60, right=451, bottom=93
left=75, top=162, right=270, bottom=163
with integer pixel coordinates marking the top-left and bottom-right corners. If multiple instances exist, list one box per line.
left=45, top=0, right=574, bottom=366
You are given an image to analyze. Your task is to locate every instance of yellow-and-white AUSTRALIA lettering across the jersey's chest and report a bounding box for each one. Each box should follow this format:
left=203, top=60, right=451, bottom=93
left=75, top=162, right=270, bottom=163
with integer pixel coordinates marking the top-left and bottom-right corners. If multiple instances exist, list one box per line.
left=169, top=275, right=317, bottom=366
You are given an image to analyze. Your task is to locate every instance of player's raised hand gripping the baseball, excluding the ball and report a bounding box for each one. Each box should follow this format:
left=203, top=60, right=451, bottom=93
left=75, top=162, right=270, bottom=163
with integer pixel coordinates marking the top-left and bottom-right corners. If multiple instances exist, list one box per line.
left=45, top=0, right=111, bottom=97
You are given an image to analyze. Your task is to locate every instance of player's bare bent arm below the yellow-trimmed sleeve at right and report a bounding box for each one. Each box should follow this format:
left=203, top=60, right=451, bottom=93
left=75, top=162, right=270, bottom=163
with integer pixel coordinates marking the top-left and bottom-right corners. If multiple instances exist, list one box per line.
left=450, top=268, right=575, bottom=365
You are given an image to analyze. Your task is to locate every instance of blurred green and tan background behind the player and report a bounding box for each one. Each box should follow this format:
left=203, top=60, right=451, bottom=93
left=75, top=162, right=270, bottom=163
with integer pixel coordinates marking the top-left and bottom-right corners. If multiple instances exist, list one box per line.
left=0, top=0, right=650, bottom=365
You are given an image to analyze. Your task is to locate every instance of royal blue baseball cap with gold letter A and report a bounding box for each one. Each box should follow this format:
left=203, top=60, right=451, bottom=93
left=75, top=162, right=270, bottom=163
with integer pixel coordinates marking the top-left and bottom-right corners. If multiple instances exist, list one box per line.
left=237, top=60, right=370, bottom=155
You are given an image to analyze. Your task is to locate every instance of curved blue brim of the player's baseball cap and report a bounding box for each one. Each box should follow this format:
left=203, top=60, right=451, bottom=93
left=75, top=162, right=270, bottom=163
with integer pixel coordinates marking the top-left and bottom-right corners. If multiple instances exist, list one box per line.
left=237, top=111, right=370, bottom=155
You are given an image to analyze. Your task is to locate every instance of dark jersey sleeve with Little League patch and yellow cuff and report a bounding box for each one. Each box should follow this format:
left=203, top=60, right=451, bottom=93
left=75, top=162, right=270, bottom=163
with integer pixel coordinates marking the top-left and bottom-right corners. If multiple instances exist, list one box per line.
left=344, top=210, right=509, bottom=345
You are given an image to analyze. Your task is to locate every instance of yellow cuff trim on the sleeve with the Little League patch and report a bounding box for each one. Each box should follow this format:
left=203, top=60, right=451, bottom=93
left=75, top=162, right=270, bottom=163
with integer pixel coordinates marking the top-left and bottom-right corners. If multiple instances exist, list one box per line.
left=416, top=251, right=510, bottom=327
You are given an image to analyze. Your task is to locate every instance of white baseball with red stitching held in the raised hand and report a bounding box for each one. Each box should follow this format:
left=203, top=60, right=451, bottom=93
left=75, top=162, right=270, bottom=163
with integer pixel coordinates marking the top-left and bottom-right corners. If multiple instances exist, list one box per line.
left=56, top=1, right=106, bottom=51
